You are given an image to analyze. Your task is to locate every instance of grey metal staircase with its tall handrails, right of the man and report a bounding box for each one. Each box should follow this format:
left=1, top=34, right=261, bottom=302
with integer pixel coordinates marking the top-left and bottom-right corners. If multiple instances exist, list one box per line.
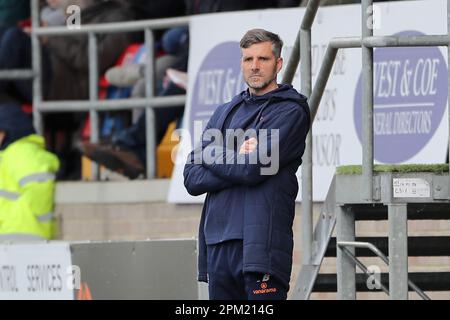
left=283, top=0, right=450, bottom=299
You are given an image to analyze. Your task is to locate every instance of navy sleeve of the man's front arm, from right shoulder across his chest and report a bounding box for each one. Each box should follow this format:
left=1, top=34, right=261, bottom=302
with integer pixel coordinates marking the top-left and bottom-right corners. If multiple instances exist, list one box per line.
left=203, top=106, right=310, bottom=185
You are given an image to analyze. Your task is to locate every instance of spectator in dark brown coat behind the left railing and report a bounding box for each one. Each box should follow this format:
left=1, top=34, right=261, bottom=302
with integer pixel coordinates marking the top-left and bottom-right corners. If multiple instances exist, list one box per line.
left=43, top=0, right=145, bottom=180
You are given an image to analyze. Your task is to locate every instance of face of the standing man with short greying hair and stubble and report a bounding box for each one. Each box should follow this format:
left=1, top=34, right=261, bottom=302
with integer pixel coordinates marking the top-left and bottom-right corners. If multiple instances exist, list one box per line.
left=241, top=41, right=283, bottom=95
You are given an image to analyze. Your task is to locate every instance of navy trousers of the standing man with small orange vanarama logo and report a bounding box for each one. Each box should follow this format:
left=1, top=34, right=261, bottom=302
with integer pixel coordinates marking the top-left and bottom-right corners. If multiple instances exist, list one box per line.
left=207, top=240, right=288, bottom=300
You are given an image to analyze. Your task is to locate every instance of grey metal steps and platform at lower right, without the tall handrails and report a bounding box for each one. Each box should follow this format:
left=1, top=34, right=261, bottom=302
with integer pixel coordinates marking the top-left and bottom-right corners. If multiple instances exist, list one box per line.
left=293, top=166, right=450, bottom=299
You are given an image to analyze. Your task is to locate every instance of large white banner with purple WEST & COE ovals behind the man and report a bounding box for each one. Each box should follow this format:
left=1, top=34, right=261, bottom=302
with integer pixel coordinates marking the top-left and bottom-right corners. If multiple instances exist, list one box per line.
left=168, top=0, right=448, bottom=203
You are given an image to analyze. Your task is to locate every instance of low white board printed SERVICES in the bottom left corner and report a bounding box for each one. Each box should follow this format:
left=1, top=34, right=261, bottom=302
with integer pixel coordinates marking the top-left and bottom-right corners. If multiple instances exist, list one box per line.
left=0, top=242, right=74, bottom=300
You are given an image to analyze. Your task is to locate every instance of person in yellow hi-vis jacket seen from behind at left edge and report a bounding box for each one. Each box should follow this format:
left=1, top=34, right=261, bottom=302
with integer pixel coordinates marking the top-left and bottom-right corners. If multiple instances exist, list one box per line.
left=0, top=104, right=59, bottom=242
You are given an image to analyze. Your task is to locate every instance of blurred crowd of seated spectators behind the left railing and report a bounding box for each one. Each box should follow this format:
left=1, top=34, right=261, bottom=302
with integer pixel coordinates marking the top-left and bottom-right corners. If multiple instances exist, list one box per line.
left=0, top=0, right=408, bottom=180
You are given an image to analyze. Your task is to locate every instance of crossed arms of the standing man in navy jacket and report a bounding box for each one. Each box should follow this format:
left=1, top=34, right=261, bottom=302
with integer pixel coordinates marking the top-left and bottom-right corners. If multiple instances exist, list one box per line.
left=184, top=106, right=309, bottom=196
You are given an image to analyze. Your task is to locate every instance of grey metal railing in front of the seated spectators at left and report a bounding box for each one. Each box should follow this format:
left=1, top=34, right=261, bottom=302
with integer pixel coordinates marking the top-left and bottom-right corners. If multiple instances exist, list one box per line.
left=26, top=0, right=190, bottom=179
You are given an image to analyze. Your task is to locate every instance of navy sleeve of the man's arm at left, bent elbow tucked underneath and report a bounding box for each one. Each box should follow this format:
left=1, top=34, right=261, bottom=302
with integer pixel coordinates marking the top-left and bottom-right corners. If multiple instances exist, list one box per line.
left=183, top=107, right=233, bottom=196
